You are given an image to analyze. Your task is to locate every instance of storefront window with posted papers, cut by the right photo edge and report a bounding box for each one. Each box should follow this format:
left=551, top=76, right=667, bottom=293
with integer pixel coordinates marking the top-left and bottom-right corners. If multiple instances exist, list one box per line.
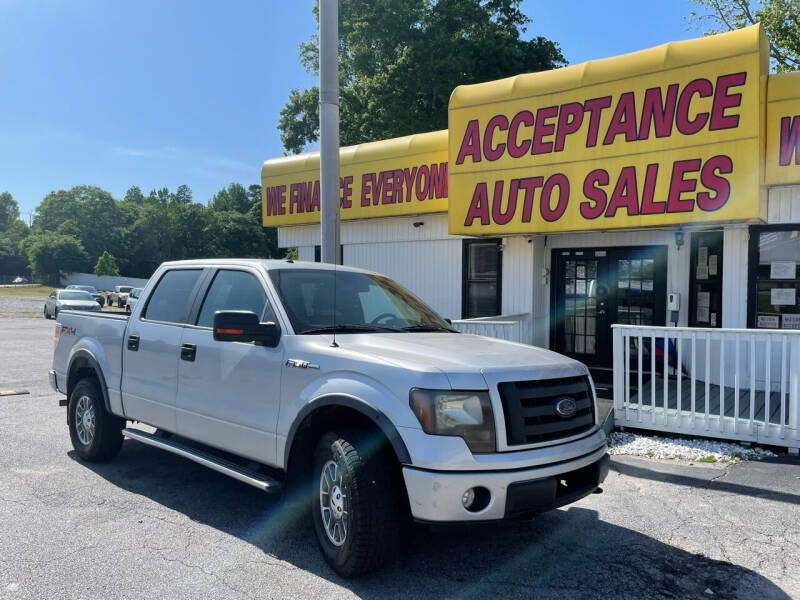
left=750, top=226, right=800, bottom=329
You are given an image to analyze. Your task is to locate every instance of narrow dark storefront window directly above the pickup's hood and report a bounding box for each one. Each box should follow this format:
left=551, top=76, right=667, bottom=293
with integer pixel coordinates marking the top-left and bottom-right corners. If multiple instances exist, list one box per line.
left=462, top=240, right=502, bottom=319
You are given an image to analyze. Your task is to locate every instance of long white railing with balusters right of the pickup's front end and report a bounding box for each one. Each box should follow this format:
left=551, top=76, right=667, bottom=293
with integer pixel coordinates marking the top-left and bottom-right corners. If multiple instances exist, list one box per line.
left=613, top=325, right=800, bottom=452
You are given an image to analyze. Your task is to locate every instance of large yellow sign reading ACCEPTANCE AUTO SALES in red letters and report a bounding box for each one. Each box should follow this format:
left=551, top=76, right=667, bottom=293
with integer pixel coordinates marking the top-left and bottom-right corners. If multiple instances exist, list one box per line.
left=449, top=26, right=768, bottom=235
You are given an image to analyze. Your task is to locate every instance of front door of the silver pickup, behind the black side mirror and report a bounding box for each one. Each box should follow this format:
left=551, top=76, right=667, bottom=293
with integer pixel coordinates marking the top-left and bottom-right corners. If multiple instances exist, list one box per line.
left=177, top=268, right=284, bottom=464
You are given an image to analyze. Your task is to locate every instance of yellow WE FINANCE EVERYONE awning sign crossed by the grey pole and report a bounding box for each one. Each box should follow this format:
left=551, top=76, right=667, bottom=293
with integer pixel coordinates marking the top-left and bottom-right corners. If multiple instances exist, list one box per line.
left=261, top=131, right=448, bottom=227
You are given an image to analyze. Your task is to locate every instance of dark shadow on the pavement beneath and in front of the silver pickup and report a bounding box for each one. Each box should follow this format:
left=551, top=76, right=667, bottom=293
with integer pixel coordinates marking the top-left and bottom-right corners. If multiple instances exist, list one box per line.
left=70, top=441, right=789, bottom=600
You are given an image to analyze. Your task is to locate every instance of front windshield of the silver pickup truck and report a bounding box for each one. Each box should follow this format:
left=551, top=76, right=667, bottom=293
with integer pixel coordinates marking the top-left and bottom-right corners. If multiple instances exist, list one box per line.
left=270, top=269, right=452, bottom=334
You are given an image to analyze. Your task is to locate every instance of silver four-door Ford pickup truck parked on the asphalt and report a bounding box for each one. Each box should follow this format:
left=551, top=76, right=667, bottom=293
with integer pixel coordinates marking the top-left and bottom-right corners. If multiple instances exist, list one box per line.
left=50, top=259, right=608, bottom=576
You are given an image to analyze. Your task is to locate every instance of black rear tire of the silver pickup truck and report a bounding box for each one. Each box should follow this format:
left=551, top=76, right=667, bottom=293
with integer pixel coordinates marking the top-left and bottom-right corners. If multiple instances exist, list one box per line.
left=67, top=378, right=125, bottom=462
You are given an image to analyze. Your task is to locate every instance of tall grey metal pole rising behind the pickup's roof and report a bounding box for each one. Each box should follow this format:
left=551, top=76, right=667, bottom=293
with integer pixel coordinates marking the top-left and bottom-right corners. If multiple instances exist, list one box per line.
left=319, top=0, right=339, bottom=264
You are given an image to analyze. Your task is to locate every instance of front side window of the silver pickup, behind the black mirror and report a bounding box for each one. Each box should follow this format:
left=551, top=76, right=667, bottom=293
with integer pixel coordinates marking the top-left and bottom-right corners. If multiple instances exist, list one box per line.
left=197, top=269, right=275, bottom=327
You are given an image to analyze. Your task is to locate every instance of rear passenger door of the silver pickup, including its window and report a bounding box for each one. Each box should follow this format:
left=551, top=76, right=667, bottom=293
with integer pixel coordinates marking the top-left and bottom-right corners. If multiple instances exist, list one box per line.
left=122, top=269, right=203, bottom=432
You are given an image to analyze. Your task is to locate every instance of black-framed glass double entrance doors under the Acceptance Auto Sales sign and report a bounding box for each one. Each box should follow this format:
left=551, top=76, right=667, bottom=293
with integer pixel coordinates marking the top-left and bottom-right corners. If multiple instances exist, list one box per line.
left=550, top=246, right=667, bottom=368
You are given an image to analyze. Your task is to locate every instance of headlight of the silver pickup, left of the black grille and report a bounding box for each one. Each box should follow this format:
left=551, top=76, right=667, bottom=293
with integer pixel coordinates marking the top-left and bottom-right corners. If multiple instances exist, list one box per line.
left=409, top=388, right=495, bottom=453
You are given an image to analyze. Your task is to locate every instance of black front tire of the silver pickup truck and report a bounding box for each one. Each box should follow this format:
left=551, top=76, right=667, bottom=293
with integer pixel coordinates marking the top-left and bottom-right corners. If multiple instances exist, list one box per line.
left=311, top=431, right=407, bottom=577
